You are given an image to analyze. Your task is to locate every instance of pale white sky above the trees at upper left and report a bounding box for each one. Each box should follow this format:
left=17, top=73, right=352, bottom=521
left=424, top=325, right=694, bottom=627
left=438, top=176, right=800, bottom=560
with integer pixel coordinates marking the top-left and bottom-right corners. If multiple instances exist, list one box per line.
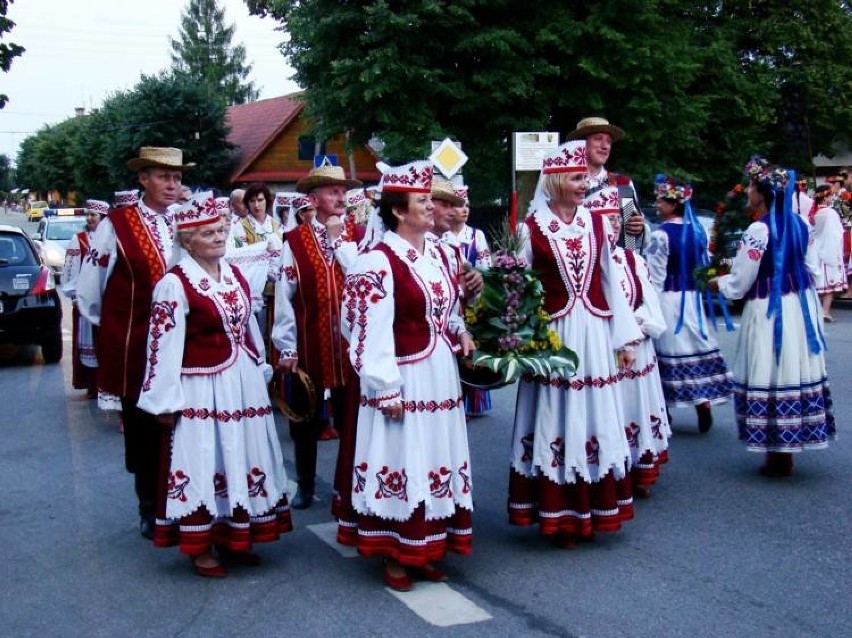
left=0, top=0, right=299, bottom=168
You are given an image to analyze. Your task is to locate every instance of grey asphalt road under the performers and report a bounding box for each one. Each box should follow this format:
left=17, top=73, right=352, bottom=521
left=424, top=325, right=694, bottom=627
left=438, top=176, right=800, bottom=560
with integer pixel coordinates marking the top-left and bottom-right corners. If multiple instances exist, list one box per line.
left=0, top=209, right=852, bottom=638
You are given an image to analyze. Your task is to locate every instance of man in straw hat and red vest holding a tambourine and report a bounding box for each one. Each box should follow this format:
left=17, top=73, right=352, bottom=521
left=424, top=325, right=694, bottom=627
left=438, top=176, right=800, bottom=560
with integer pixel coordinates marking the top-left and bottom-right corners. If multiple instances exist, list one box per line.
left=272, top=158, right=361, bottom=509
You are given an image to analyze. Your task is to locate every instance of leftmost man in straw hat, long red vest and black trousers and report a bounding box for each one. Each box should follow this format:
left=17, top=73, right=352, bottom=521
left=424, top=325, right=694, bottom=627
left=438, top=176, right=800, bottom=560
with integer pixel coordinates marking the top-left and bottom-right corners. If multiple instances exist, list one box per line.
left=77, top=146, right=194, bottom=538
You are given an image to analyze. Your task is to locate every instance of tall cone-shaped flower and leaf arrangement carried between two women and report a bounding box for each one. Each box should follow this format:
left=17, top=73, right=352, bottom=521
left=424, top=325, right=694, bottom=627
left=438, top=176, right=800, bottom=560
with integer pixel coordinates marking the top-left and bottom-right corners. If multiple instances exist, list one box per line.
left=463, top=223, right=578, bottom=385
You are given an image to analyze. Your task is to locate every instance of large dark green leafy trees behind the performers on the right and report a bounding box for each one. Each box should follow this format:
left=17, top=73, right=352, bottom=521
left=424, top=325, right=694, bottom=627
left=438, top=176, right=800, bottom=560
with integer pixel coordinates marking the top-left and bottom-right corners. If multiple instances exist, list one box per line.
left=246, top=0, right=852, bottom=204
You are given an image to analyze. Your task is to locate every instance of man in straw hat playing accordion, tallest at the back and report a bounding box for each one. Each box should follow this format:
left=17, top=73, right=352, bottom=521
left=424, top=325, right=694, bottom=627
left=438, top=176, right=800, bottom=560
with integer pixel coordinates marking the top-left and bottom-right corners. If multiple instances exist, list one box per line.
left=567, top=117, right=645, bottom=250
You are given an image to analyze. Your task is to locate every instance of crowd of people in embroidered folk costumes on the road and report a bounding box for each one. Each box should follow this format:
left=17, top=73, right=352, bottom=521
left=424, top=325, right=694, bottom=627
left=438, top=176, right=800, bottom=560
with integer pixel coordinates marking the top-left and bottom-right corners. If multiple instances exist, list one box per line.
left=63, top=117, right=846, bottom=591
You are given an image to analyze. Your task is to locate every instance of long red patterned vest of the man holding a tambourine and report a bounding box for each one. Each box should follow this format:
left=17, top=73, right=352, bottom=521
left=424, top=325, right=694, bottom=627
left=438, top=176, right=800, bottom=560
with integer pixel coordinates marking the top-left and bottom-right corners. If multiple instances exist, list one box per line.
left=287, top=224, right=348, bottom=389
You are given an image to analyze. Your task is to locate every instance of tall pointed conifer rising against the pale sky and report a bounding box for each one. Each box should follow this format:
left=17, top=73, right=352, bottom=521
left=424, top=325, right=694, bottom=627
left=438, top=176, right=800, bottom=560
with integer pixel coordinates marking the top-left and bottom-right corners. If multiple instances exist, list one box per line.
left=170, top=0, right=258, bottom=104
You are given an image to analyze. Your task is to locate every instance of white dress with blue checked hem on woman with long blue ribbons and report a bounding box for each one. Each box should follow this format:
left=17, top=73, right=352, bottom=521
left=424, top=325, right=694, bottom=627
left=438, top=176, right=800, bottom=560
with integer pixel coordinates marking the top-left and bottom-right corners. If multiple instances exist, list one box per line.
left=719, top=217, right=835, bottom=452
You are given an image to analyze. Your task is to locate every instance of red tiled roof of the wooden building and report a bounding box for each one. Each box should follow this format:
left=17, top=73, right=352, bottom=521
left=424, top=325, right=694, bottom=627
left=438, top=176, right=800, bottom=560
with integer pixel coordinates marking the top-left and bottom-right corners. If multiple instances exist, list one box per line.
left=225, top=96, right=305, bottom=182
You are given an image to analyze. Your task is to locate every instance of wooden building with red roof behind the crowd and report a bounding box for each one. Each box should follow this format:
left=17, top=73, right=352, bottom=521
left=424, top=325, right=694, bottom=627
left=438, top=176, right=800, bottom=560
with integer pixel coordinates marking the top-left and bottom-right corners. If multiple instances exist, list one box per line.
left=226, top=93, right=381, bottom=191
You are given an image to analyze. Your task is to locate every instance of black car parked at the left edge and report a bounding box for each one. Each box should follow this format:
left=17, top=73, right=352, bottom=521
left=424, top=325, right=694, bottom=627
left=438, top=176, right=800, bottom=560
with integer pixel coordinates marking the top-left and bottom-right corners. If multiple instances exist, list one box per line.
left=0, top=225, right=62, bottom=363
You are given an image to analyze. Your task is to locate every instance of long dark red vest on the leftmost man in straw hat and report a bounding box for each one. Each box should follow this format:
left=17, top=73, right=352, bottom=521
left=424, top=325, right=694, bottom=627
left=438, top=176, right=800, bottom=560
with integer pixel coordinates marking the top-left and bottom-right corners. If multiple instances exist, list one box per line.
left=98, top=206, right=166, bottom=401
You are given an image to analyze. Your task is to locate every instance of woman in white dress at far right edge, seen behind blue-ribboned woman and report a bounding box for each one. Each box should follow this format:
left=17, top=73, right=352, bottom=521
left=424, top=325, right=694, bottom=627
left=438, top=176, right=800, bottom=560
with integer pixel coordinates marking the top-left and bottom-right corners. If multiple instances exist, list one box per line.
left=810, top=185, right=847, bottom=323
